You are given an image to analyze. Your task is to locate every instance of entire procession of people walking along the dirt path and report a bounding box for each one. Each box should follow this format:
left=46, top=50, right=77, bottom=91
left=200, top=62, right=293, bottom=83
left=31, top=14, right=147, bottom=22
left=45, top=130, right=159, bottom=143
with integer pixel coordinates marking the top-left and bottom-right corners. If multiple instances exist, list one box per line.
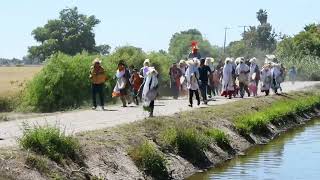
left=90, top=42, right=297, bottom=117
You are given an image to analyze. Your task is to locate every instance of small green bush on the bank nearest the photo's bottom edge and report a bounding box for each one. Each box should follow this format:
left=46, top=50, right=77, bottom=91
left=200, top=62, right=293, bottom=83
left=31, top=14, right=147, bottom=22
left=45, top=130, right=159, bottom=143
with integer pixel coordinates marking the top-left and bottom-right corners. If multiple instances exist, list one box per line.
left=130, top=141, right=169, bottom=179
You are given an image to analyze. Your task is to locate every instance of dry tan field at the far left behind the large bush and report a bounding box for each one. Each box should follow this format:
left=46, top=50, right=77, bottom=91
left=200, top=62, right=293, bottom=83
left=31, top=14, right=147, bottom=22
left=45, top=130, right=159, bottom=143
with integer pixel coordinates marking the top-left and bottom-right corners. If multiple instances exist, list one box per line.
left=0, top=66, right=42, bottom=97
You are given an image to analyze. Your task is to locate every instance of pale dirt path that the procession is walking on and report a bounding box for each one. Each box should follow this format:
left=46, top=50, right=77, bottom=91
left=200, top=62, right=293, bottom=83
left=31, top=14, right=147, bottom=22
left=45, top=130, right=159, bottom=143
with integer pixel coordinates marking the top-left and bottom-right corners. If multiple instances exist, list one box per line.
left=0, top=82, right=320, bottom=147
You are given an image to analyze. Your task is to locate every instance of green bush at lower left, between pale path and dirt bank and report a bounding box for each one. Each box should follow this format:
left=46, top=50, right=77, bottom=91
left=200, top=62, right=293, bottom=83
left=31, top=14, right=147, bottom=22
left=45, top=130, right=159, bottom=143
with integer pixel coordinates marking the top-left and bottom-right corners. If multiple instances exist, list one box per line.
left=19, top=125, right=81, bottom=163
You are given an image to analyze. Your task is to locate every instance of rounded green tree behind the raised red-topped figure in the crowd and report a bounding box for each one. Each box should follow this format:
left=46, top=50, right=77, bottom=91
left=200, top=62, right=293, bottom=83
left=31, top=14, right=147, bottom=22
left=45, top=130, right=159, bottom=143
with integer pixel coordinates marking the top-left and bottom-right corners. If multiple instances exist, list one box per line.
left=169, top=29, right=218, bottom=60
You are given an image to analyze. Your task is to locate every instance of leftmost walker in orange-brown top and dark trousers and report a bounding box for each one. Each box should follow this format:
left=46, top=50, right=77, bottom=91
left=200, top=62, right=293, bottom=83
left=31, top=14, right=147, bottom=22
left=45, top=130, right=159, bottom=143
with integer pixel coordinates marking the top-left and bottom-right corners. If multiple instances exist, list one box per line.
left=89, top=58, right=107, bottom=110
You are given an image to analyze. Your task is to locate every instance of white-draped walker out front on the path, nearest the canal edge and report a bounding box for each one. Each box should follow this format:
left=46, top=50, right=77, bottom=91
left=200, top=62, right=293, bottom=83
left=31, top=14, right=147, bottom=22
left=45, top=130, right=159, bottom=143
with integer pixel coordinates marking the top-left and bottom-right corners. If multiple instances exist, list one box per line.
left=142, top=67, right=159, bottom=117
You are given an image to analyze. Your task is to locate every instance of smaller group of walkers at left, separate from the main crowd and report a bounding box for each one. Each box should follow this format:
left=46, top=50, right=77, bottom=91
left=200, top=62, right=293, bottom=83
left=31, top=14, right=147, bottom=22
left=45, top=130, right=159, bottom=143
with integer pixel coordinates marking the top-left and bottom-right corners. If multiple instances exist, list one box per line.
left=89, top=58, right=158, bottom=117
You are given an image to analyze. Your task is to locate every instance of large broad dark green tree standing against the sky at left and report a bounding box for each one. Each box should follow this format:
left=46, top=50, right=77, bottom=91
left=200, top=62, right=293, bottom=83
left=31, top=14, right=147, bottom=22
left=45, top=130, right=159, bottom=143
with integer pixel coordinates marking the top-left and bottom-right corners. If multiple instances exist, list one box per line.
left=29, top=7, right=100, bottom=61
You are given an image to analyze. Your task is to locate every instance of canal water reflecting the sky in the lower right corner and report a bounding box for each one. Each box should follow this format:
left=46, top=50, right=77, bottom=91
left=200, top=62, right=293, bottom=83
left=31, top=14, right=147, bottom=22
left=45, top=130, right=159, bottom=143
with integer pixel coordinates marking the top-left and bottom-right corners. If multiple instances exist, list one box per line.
left=188, top=120, right=320, bottom=180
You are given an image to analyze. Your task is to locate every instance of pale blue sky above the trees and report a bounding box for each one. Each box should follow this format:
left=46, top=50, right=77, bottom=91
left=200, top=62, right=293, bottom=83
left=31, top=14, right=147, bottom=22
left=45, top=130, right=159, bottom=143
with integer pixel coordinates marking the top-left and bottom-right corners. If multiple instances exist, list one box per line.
left=0, top=0, right=320, bottom=58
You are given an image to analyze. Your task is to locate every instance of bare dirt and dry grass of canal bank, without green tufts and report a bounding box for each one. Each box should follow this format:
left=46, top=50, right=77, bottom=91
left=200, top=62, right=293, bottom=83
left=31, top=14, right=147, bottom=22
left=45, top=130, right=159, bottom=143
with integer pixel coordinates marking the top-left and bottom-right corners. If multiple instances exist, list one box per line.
left=0, top=92, right=320, bottom=179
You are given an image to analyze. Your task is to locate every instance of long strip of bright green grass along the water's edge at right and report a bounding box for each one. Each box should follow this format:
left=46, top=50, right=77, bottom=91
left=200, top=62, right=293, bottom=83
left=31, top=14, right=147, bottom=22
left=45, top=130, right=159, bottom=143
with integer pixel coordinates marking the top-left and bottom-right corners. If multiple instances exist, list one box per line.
left=235, top=92, right=320, bottom=134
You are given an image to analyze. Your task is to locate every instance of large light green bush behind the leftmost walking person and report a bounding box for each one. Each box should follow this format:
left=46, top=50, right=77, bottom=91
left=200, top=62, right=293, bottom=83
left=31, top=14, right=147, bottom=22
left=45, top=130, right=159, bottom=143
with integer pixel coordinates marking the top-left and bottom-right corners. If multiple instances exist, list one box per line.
left=22, top=53, right=115, bottom=112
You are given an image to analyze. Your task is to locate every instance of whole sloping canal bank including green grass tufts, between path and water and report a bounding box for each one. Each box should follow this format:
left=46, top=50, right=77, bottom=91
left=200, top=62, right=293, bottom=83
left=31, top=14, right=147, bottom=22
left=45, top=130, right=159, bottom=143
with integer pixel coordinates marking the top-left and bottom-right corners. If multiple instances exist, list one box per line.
left=0, top=89, right=320, bottom=179
